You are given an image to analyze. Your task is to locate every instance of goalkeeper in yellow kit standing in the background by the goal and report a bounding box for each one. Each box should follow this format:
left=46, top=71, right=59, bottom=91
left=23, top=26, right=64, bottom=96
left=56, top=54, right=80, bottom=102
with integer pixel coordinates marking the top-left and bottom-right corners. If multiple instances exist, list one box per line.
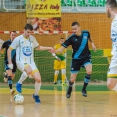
left=52, top=38, right=66, bottom=85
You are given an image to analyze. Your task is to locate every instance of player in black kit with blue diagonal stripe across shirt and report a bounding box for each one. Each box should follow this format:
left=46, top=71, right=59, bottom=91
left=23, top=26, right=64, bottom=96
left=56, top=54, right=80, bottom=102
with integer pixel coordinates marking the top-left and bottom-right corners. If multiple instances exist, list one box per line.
left=55, top=22, right=96, bottom=98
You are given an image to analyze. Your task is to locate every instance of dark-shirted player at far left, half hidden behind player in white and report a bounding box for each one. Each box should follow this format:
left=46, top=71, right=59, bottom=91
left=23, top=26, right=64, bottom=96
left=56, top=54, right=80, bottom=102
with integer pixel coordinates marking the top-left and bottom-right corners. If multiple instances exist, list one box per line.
left=1, top=31, right=17, bottom=95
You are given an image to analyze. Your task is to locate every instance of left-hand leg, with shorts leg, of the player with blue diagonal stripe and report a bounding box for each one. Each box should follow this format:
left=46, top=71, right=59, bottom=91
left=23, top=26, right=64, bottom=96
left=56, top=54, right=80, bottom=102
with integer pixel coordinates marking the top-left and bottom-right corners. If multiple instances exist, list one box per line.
left=66, top=59, right=80, bottom=98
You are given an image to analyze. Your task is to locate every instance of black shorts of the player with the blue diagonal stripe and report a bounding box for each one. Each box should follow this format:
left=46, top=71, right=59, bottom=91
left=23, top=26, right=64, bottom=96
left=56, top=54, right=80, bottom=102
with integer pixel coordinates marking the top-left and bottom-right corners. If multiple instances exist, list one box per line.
left=71, top=56, right=92, bottom=73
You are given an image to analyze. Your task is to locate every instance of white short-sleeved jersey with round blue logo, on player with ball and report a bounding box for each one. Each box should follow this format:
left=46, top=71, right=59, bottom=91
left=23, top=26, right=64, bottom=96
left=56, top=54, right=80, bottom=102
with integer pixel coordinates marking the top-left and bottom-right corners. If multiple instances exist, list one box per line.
left=10, top=35, right=39, bottom=64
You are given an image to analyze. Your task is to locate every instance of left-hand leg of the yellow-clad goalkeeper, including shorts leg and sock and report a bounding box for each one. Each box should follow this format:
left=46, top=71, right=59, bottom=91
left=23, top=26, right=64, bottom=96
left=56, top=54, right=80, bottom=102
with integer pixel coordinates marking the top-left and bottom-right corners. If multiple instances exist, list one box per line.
left=54, top=60, right=60, bottom=85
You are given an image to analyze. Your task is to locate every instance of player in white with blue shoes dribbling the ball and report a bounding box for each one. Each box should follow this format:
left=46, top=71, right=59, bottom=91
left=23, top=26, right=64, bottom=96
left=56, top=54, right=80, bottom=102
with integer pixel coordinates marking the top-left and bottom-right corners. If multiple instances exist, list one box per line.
left=7, top=24, right=53, bottom=103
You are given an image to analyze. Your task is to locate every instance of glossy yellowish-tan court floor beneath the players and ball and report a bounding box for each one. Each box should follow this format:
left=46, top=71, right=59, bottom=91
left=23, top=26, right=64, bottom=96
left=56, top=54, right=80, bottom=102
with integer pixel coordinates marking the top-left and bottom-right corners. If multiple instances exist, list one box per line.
left=0, top=87, right=117, bottom=117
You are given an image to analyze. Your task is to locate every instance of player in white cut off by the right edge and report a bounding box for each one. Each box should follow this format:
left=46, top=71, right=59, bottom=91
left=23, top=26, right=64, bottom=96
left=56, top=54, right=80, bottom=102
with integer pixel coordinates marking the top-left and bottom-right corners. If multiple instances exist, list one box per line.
left=106, top=0, right=117, bottom=91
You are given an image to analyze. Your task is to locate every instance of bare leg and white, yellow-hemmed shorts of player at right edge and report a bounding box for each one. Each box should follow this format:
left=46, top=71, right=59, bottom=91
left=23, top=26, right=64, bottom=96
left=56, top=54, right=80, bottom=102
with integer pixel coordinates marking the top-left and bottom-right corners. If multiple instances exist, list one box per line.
left=107, top=58, right=117, bottom=92
